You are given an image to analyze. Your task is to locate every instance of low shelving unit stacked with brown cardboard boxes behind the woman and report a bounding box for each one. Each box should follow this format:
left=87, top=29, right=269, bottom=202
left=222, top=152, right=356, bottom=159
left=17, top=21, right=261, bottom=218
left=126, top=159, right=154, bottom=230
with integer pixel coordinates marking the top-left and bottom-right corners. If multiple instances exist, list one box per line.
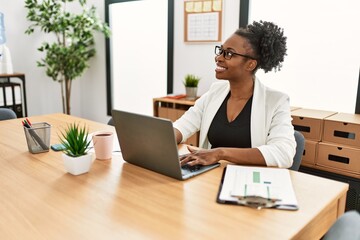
left=291, top=109, right=360, bottom=211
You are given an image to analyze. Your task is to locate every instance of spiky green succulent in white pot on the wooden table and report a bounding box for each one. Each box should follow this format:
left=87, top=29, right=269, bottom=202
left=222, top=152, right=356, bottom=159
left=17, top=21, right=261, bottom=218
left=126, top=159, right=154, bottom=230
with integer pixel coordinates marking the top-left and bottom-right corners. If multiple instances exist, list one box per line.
left=59, top=123, right=93, bottom=175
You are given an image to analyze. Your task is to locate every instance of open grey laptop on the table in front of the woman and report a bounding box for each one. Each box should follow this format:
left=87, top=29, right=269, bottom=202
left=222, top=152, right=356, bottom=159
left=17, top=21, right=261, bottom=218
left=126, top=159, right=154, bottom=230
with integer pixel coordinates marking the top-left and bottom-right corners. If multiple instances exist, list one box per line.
left=112, top=110, right=220, bottom=180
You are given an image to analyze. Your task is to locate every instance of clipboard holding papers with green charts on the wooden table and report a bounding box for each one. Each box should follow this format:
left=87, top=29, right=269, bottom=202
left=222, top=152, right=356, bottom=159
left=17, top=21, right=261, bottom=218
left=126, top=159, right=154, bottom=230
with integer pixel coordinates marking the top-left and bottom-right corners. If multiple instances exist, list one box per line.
left=216, top=165, right=299, bottom=211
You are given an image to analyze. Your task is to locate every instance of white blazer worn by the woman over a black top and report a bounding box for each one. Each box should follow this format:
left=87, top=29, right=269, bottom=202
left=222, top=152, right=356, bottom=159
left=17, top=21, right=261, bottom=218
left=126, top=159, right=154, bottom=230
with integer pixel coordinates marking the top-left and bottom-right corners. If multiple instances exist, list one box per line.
left=174, top=78, right=296, bottom=168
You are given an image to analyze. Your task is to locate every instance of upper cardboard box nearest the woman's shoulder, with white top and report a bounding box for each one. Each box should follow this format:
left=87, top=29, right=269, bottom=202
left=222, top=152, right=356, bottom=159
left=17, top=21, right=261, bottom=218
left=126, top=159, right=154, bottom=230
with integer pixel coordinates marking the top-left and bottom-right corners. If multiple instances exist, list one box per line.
left=291, top=108, right=336, bottom=141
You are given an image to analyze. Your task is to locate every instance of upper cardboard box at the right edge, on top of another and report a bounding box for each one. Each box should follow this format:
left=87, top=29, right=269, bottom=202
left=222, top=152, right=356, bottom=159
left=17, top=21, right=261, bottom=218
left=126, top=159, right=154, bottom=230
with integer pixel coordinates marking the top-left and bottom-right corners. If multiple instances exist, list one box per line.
left=323, top=113, right=360, bottom=147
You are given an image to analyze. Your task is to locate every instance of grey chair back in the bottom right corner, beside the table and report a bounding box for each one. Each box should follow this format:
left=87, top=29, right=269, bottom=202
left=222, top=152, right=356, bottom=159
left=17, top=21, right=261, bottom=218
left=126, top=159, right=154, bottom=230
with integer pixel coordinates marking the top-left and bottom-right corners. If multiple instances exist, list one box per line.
left=322, top=210, right=360, bottom=240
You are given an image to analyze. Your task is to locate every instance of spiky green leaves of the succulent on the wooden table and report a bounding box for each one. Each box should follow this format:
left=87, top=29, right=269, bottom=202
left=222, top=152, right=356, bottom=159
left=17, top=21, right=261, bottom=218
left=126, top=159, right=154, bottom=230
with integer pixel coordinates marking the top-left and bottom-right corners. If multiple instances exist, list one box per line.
left=59, top=123, right=91, bottom=157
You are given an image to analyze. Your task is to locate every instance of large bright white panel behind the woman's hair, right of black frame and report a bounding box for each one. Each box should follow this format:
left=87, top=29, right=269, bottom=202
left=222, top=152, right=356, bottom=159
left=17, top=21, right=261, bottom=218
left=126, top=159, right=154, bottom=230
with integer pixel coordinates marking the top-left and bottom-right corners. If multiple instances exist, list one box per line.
left=250, top=0, right=360, bottom=113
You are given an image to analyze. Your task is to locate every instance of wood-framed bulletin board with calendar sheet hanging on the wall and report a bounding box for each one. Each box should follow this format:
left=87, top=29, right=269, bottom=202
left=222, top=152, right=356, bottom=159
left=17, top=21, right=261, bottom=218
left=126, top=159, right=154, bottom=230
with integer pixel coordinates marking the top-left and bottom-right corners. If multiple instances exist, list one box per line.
left=184, top=0, right=223, bottom=42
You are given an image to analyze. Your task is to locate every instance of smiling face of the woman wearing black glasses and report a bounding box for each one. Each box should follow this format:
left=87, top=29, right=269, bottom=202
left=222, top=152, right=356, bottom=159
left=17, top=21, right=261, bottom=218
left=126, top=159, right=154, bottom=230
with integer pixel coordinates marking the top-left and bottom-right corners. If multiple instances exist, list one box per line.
left=215, top=34, right=256, bottom=81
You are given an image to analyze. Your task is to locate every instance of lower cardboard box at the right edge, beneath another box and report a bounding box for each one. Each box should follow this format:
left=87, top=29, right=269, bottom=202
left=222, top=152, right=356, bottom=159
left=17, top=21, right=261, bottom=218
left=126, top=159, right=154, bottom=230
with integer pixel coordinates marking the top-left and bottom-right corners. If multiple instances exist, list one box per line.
left=315, top=142, right=360, bottom=174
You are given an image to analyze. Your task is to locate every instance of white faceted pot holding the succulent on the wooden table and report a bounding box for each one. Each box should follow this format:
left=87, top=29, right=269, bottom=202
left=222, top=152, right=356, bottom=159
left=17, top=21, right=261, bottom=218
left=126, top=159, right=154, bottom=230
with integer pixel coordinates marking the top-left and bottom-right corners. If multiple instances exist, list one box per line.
left=62, top=153, right=93, bottom=175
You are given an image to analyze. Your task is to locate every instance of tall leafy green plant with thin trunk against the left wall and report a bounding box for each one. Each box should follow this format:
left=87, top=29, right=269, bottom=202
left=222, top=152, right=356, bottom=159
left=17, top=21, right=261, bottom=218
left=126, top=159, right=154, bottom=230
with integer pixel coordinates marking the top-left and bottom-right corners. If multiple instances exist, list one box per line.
left=25, top=0, right=110, bottom=114
